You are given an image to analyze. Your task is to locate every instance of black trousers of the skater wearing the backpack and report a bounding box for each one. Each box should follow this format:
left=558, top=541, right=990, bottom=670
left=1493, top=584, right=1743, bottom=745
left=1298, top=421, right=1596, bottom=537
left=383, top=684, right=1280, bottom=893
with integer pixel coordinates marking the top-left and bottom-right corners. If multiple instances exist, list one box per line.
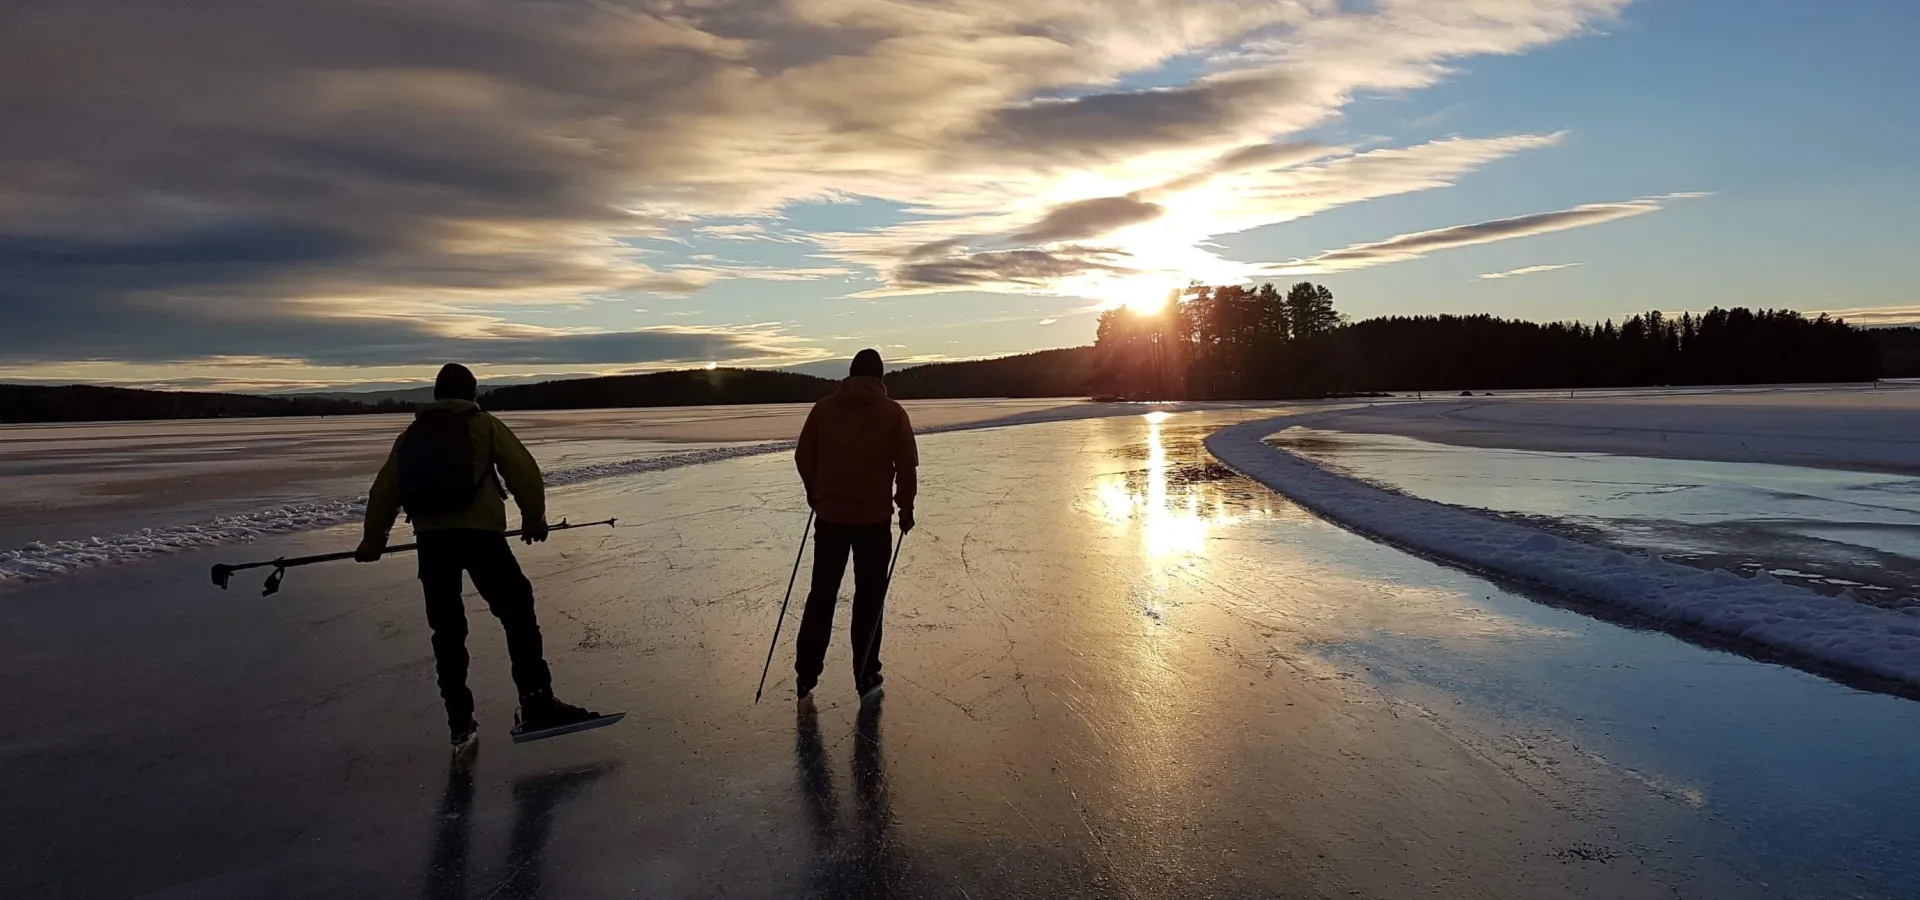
left=419, top=528, right=553, bottom=723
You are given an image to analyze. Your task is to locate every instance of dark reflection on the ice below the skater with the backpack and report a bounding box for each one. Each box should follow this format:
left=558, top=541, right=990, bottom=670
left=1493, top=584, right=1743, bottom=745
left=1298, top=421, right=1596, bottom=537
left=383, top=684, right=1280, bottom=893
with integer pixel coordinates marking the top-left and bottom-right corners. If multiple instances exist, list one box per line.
left=420, top=760, right=614, bottom=900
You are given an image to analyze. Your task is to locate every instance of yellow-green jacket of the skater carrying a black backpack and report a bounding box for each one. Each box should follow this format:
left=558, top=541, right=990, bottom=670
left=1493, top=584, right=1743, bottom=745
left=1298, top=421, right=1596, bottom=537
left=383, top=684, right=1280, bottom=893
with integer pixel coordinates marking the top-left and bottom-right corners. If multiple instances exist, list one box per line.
left=367, top=399, right=547, bottom=541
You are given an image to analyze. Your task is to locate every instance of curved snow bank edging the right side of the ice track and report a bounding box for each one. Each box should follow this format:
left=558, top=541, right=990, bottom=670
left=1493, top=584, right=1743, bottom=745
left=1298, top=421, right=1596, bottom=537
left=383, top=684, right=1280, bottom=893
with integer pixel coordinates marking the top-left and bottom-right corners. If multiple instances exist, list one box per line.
left=1206, top=416, right=1920, bottom=685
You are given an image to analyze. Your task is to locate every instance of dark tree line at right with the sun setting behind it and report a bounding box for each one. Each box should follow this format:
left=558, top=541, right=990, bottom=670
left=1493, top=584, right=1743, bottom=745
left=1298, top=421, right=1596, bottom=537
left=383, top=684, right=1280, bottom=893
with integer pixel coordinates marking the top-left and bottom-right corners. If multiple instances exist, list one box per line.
left=1094, top=282, right=1882, bottom=399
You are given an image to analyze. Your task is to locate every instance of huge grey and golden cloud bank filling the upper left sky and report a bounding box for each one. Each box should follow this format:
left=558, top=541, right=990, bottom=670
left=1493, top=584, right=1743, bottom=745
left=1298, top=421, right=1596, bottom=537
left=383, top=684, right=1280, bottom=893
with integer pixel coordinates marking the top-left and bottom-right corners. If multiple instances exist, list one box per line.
left=0, top=0, right=1626, bottom=368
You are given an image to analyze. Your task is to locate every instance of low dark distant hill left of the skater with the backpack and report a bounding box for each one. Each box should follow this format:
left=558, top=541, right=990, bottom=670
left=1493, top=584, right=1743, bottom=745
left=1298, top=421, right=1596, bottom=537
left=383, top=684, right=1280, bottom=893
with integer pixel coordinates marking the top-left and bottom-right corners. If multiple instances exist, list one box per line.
left=0, top=384, right=405, bottom=422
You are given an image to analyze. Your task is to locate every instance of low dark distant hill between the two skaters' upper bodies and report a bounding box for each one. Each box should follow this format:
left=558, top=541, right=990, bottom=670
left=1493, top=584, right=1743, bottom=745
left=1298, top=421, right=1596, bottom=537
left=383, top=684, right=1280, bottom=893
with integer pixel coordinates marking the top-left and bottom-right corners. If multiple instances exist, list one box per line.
left=486, top=368, right=835, bottom=409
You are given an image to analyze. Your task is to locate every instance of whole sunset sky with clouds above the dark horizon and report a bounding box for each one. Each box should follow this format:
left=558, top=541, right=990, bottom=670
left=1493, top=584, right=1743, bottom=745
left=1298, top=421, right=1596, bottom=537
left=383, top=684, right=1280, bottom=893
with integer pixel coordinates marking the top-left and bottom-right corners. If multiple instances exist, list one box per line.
left=0, top=0, right=1920, bottom=390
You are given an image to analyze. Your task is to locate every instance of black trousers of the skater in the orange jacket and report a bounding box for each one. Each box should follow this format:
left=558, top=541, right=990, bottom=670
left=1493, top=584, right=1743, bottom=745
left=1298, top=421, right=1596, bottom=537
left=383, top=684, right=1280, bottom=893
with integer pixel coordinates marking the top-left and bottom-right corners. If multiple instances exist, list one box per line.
left=793, top=522, right=893, bottom=691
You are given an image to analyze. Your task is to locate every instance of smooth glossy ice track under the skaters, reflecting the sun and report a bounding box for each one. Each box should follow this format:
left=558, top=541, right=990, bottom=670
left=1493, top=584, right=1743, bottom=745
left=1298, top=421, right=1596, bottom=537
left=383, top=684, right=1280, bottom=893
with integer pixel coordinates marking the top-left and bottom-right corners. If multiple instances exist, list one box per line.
left=0, top=402, right=1920, bottom=898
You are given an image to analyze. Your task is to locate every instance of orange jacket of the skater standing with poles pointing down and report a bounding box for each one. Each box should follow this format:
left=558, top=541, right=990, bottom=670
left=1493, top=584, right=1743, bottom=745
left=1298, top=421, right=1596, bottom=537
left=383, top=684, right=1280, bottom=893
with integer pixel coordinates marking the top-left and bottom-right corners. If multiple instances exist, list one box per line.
left=793, top=376, right=920, bottom=526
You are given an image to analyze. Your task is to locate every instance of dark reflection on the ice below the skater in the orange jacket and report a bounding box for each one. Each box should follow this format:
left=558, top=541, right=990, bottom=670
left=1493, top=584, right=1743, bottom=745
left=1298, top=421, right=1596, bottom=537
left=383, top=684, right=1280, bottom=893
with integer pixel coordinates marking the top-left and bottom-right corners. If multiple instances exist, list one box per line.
left=793, top=700, right=895, bottom=898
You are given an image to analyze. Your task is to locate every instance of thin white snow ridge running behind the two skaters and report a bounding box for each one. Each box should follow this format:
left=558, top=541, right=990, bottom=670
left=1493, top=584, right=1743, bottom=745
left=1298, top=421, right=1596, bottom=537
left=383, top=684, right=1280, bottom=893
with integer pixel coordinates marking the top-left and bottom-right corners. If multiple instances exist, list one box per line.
left=0, top=403, right=1139, bottom=585
